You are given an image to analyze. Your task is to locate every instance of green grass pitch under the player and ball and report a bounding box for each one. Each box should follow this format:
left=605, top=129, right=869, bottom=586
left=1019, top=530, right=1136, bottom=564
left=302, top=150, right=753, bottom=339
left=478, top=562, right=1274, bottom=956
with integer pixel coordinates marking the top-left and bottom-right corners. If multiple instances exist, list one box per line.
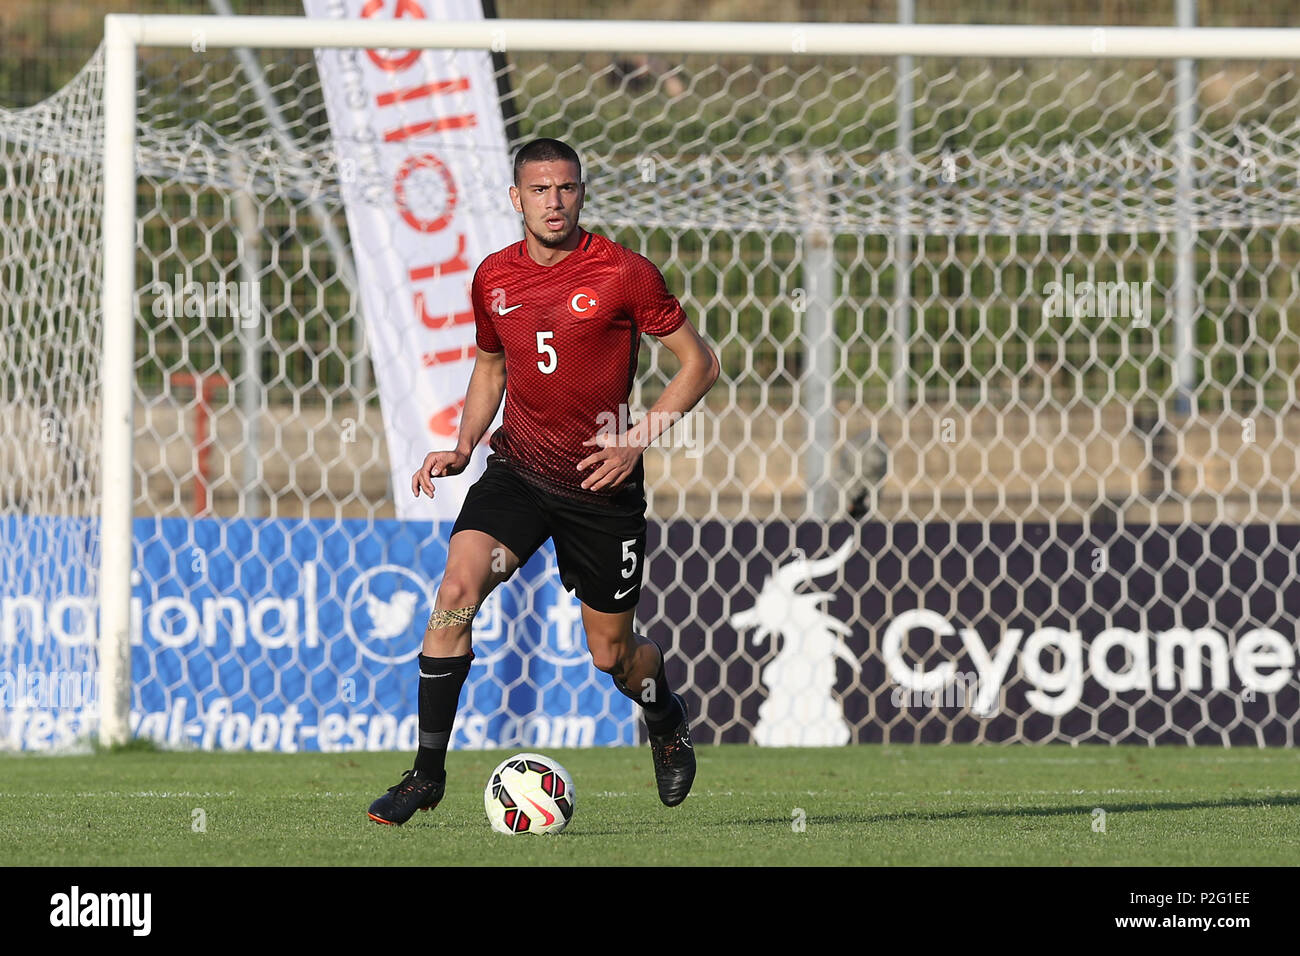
left=0, top=745, right=1300, bottom=866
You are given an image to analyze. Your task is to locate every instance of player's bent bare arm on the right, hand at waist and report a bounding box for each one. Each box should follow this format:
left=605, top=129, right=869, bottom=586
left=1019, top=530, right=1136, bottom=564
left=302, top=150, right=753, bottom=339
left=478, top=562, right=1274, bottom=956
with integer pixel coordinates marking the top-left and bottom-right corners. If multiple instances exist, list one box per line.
left=577, top=320, right=722, bottom=492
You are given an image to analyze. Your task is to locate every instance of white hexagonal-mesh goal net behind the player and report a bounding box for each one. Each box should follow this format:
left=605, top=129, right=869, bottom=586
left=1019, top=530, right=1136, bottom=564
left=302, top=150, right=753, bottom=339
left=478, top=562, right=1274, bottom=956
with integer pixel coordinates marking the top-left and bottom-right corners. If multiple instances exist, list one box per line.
left=0, top=13, right=1300, bottom=750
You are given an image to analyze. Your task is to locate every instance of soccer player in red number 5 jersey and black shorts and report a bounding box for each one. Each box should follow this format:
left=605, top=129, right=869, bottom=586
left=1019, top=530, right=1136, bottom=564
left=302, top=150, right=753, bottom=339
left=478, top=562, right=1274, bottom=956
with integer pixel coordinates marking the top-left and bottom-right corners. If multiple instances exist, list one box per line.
left=369, top=139, right=719, bottom=823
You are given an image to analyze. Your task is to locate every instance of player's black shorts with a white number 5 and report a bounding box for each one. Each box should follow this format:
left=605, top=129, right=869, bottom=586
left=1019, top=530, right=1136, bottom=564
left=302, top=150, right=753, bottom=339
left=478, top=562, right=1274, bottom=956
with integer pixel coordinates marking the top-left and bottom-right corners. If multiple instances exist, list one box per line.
left=451, top=457, right=646, bottom=614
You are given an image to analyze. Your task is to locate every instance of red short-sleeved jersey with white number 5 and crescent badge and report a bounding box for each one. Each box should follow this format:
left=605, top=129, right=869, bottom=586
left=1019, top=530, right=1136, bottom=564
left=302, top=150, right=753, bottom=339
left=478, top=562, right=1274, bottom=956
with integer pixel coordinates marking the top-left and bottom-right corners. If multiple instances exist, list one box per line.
left=471, top=228, right=686, bottom=499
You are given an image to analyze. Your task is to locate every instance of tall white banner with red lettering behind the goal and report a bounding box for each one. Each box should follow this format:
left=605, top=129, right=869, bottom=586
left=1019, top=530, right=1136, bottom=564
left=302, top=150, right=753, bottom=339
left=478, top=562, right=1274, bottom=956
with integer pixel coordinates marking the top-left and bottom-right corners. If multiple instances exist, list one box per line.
left=303, top=0, right=523, bottom=520
